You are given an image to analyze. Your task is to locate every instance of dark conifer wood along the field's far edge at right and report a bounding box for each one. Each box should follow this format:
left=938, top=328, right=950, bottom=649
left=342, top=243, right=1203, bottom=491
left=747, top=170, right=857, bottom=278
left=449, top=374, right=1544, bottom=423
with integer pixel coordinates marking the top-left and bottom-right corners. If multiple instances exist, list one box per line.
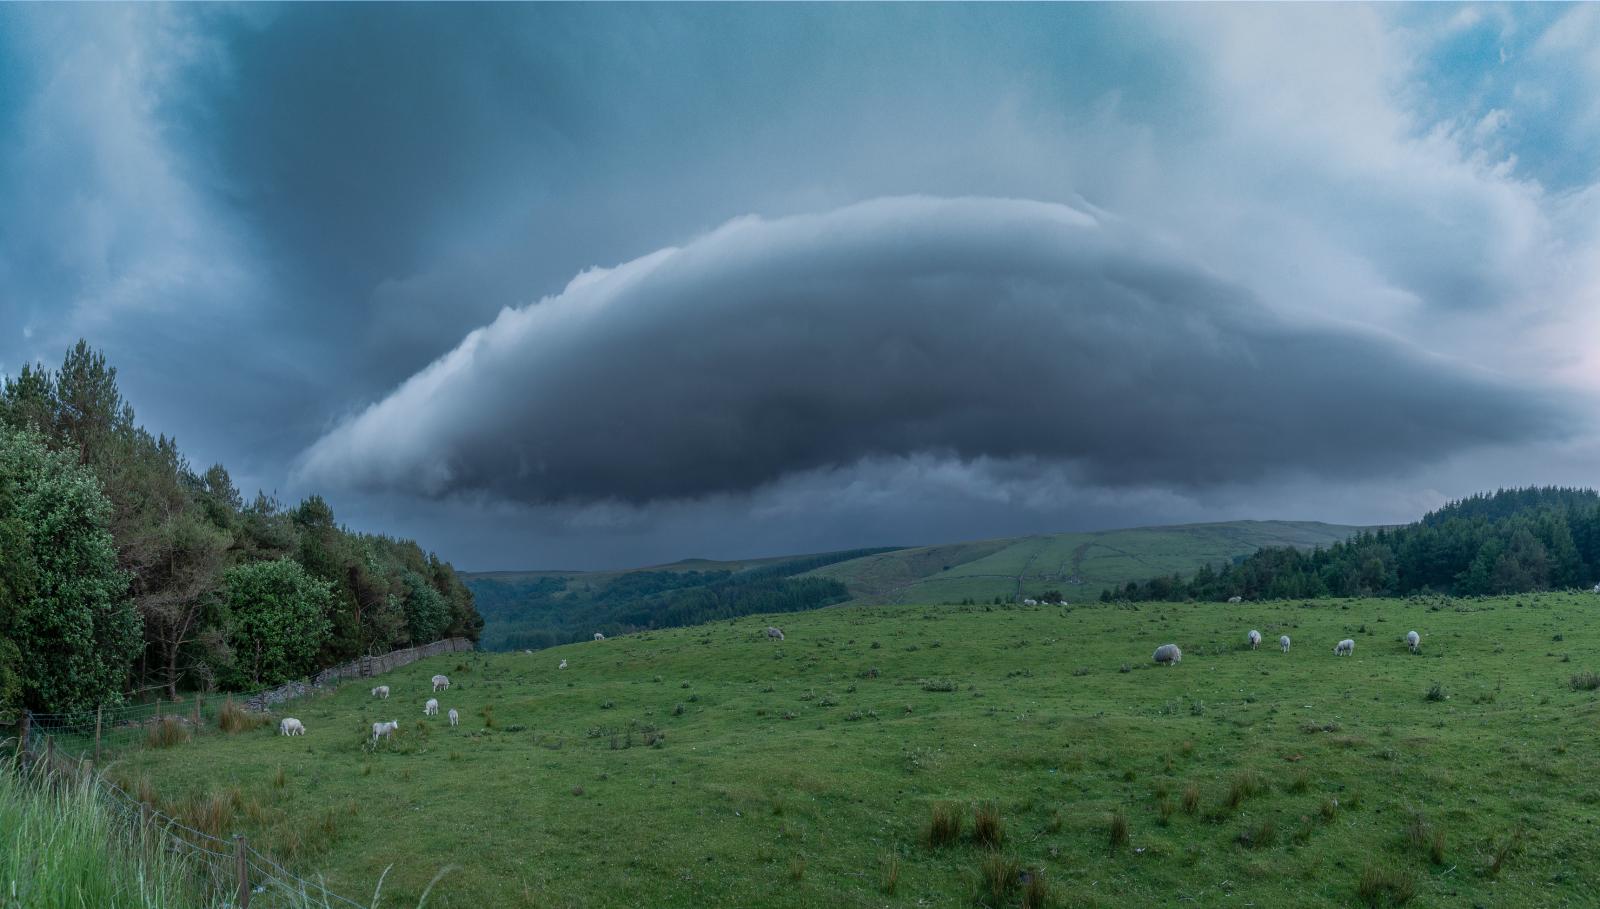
left=1101, top=487, right=1600, bottom=600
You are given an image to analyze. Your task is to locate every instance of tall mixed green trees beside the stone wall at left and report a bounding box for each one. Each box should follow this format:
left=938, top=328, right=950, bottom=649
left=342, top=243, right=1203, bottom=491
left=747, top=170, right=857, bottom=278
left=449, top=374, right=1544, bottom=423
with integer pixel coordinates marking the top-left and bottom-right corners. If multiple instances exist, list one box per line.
left=0, top=341, right=482, bottom=722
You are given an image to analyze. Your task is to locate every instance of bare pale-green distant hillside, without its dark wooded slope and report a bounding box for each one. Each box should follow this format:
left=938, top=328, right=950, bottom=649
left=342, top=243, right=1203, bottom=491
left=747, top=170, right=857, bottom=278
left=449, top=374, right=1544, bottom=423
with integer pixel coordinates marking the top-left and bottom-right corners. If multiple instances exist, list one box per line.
left=810, top=520, right=1368, bottom=605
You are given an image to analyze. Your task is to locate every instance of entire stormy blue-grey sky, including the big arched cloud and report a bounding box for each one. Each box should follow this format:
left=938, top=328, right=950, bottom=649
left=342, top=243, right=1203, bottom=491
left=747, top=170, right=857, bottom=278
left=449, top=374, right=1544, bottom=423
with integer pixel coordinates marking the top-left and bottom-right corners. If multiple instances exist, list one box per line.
left=0, top=5, right=1600, bottom=568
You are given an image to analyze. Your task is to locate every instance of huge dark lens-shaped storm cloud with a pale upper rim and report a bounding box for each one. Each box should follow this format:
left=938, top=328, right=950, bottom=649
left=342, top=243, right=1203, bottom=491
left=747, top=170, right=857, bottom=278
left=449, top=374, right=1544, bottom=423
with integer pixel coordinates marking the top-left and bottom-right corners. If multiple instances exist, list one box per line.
left=301, top=197, right=1563, bottom=504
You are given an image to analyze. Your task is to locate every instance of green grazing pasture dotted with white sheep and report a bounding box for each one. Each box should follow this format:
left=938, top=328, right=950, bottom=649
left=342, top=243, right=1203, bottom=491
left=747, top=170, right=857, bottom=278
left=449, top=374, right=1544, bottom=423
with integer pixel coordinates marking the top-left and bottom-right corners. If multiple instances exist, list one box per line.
left=110, top=594, right=1600, bottom=909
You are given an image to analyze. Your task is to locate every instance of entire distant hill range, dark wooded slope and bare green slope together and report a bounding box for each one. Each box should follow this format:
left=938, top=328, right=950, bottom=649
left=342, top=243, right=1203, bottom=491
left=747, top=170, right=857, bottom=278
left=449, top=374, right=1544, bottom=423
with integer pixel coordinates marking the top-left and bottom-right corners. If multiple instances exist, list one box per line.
left=462, top=520, right=1362, bottom=650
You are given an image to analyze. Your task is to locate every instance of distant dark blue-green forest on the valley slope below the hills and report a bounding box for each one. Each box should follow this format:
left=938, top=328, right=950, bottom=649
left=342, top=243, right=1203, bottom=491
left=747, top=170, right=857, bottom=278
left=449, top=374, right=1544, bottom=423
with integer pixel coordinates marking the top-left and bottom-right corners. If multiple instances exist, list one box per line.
left=469, top=549, right=890, bottom=650
